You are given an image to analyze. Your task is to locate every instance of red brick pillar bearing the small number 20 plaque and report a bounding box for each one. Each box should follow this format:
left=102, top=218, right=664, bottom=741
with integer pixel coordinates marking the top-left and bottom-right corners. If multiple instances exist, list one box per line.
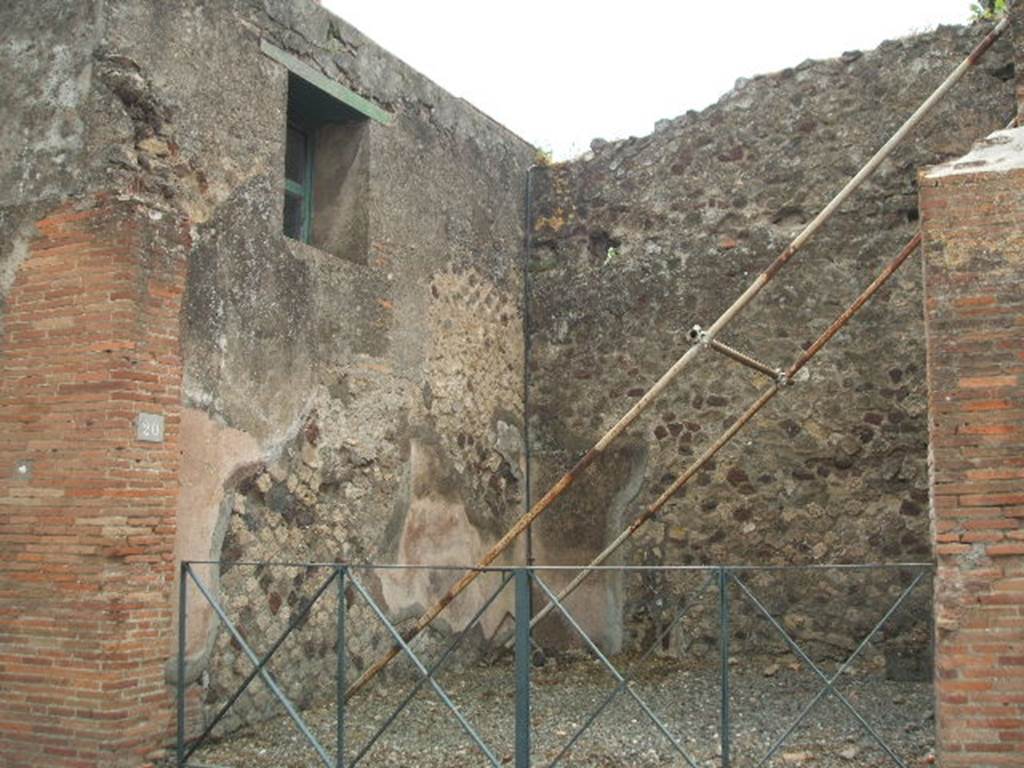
left=0, top=200, right=184, bottom=768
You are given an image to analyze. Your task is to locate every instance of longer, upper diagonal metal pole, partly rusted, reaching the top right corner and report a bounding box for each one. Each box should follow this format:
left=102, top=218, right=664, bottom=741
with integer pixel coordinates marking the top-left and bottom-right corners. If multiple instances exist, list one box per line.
left=346, top=18, right=1010, bottom=696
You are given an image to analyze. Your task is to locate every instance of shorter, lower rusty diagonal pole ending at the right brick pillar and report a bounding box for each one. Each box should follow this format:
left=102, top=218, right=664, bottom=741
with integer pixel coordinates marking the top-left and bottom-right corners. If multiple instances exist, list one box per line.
left=516, top=232, right=921, bottom=642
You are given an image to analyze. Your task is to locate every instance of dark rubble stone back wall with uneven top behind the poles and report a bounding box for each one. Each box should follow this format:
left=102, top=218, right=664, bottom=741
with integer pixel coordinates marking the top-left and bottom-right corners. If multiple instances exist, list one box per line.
left=529, top=20, right=1014, bottom=652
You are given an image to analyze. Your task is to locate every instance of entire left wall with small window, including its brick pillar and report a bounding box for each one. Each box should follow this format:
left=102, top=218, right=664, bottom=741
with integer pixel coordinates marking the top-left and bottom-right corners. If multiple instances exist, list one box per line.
left=0, top=0, right=535, bottom=766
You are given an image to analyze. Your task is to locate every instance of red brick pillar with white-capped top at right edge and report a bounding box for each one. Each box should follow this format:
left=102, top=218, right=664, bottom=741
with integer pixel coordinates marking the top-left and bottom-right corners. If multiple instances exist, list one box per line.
left=921, top=134, right=1024, bottom=768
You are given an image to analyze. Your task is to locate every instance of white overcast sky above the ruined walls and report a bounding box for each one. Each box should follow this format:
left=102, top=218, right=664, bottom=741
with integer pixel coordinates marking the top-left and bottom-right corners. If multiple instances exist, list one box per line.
left=323, top=0, right=983, bottom=159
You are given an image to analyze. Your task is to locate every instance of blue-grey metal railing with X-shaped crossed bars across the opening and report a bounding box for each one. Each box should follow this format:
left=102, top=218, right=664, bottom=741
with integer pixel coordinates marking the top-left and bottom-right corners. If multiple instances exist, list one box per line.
left=176, top=561, right=933, bottom=768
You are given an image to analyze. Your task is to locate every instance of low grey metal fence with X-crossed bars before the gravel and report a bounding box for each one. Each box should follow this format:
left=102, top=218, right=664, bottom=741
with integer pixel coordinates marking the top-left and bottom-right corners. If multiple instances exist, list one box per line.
left=176, top=561, right=933, bottom=768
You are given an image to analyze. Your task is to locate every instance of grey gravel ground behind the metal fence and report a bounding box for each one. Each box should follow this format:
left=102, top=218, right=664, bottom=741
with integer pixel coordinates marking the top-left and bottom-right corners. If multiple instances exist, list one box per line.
left=180, top=656, right=935, bottom=768
